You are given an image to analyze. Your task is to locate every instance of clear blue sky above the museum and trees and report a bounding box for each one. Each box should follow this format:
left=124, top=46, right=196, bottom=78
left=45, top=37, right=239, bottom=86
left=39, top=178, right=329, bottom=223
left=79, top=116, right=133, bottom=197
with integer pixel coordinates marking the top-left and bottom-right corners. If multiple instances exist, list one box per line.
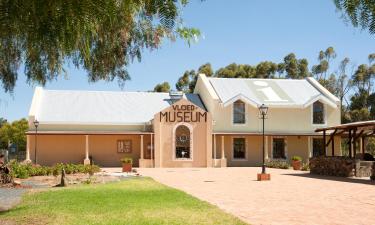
left=0, top=0, right=375, bottom=121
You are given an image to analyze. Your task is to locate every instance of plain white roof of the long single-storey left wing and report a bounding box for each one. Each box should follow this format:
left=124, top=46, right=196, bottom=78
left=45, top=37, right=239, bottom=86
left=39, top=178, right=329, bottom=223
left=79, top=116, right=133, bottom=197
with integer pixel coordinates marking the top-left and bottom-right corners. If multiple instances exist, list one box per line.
left=29, top=88, right=205, bottom=125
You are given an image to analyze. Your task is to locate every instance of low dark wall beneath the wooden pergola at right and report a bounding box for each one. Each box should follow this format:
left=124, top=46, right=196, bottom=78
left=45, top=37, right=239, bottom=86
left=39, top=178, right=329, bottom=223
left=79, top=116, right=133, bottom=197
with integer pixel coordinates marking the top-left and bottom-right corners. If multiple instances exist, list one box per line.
left=309, top=156, right=355, bottom=177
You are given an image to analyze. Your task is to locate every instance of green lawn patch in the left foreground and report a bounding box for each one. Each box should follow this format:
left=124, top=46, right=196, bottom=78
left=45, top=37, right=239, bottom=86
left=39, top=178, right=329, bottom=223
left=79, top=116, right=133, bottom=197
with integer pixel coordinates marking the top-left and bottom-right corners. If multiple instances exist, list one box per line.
left=0, top=178, right=244, bottom=225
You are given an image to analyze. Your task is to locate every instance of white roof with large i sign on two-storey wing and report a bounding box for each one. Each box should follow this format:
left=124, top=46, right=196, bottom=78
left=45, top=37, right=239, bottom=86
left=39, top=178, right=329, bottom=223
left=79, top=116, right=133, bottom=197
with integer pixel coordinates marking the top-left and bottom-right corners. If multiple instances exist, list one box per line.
left=208, top=77, right=340, bottom=108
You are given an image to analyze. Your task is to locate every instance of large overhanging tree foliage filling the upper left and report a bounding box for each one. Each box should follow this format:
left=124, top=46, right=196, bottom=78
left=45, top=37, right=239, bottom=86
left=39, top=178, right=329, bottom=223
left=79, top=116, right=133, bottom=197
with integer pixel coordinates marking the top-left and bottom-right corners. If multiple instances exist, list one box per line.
left=0, top=0, right=200, bottom=92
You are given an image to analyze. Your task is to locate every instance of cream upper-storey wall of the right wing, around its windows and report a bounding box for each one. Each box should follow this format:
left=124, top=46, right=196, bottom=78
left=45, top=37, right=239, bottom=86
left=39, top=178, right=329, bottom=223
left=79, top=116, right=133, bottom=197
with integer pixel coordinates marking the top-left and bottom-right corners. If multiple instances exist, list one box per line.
left=194, top=76, right=341, bottom=134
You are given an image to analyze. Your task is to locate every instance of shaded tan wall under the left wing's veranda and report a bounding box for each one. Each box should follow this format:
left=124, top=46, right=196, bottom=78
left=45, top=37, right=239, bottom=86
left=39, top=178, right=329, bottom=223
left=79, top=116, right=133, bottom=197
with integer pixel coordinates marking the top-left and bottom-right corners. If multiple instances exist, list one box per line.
left=28, top=135, right=151, bottom=167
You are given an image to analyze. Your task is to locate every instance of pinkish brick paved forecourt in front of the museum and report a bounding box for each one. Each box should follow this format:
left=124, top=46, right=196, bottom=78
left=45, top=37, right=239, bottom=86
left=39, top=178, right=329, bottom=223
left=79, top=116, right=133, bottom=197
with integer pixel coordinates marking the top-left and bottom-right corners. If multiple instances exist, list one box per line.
left=138, top=167, right=375, bottom=225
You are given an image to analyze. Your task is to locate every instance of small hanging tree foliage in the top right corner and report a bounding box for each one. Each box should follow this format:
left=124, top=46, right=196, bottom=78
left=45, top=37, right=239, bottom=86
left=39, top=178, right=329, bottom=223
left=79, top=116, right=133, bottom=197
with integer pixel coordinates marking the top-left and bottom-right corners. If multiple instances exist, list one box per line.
left=334, top=0, right=375, bottom=34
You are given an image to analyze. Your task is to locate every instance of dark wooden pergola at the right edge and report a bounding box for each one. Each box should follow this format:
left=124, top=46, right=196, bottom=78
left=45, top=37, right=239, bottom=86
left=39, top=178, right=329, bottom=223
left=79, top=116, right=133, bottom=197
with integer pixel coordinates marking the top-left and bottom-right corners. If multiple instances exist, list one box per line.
left=315, top=120, right=375, bottom=158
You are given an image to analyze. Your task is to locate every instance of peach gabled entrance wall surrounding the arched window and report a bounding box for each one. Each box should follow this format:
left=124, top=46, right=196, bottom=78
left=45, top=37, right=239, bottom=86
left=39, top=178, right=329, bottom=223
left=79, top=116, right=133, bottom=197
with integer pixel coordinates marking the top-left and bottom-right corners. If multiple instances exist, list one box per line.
left=154, top=99, right=212, bottom=167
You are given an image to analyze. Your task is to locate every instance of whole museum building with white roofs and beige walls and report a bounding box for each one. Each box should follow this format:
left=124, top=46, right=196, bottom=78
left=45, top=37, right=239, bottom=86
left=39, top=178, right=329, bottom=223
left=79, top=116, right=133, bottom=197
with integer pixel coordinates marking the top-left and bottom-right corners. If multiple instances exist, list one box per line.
left=26, top=74, right=341, bottom=167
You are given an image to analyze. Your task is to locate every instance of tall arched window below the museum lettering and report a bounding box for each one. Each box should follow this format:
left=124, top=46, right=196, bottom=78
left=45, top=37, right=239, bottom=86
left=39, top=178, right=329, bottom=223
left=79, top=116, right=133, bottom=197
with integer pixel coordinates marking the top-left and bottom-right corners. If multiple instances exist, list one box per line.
left=175, top=125, right=191, bottom=159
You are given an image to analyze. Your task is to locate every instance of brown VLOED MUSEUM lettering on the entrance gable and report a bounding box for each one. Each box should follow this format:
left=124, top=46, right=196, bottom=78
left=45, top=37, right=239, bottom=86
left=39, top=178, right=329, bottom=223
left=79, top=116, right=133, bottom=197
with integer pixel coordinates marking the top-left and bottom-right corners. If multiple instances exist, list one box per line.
left=160, top=105, right=207, bottom=123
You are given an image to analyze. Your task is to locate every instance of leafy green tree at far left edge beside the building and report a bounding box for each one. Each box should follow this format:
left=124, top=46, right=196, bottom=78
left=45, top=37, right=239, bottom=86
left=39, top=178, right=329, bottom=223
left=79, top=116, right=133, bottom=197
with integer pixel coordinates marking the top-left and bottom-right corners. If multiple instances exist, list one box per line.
left=0, top=119, right=29, bottom=151
